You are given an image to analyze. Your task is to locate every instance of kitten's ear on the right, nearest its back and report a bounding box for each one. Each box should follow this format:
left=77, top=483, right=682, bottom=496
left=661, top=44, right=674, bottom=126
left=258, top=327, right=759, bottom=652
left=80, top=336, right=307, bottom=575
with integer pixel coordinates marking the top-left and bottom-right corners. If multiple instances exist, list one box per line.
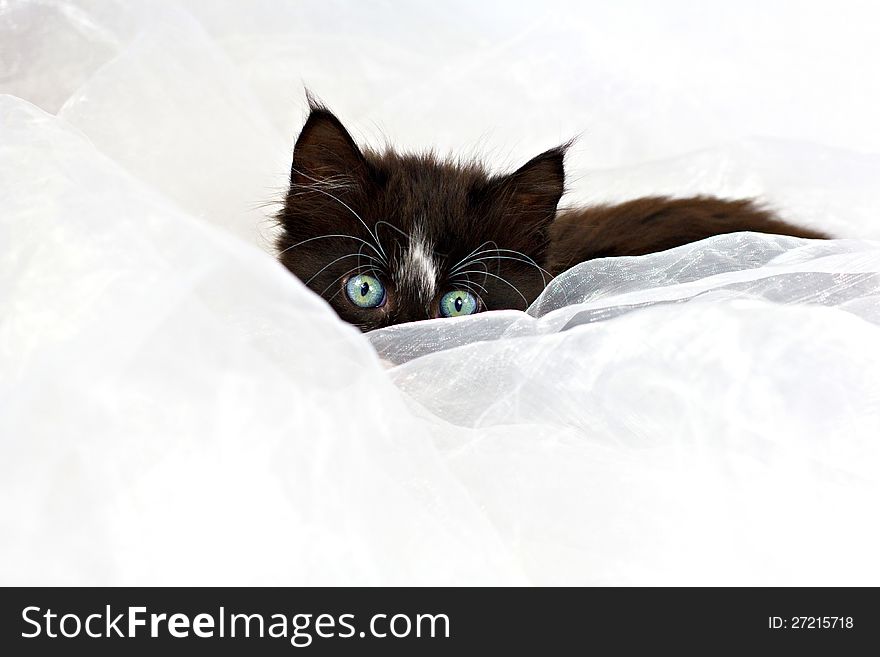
left=497, top=144, right=568, bottom=228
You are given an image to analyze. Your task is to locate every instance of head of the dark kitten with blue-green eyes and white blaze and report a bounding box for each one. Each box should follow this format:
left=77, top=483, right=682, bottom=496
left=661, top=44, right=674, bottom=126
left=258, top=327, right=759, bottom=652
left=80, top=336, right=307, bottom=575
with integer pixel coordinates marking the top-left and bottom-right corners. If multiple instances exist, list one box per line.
left=277, top=102, right=565, bottom=331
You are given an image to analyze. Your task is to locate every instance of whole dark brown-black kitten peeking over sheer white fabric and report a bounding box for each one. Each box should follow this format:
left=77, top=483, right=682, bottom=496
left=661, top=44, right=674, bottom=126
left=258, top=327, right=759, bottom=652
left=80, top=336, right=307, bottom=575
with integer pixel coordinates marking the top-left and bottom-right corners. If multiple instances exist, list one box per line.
left=277, top=102, right=824, bottom=331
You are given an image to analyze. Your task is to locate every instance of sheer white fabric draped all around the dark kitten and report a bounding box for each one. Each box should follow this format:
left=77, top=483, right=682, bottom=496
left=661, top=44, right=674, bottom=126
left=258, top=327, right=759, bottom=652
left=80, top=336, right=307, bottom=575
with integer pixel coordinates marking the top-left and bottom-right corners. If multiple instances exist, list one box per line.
left=0, top=0, right=880, bottom=585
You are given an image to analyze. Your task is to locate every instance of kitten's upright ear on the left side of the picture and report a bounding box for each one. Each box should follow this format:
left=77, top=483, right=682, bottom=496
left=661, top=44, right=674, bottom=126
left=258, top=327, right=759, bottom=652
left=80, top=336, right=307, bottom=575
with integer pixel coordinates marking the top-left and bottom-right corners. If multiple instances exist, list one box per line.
left=290, top=104, right=367, bottom=185
